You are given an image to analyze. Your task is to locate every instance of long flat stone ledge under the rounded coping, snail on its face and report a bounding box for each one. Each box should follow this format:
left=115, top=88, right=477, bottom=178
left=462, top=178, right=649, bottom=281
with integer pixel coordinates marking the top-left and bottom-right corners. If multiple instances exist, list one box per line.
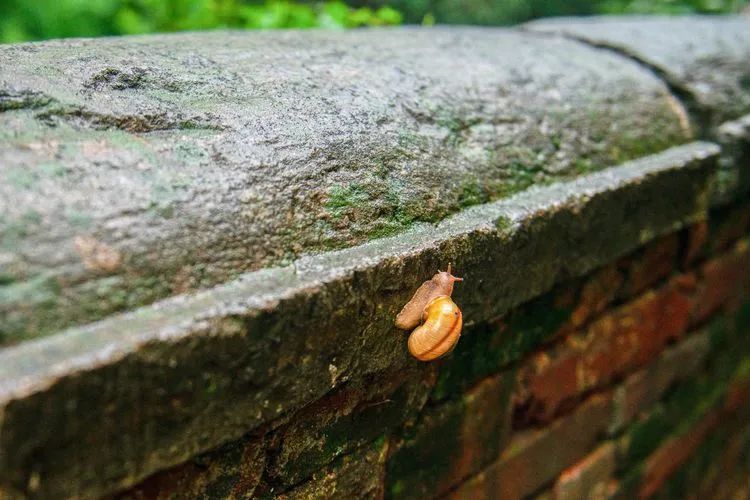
left=0, top=143, right=719, bottom=496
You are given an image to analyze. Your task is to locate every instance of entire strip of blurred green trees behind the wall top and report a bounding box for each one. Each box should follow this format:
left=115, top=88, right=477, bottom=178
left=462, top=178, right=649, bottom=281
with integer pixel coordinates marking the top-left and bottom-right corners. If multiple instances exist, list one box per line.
left=0, top=0, right=750, bottom=42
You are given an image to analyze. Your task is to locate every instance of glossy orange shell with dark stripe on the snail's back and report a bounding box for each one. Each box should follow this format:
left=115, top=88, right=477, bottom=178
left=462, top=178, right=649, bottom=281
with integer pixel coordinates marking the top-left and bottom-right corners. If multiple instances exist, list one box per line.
left=409, top=295, right=463, bottom=361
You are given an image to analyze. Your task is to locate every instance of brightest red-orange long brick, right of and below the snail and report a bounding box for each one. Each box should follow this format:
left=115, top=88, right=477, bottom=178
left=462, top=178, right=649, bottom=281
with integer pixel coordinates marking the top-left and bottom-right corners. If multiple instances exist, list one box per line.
left=516, top=275, right=693, bottom=424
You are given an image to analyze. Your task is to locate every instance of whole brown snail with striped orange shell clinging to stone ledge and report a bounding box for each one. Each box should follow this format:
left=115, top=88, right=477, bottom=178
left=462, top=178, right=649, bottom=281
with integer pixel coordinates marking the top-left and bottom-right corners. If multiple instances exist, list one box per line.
left=396, top=264, right=463, bottom=361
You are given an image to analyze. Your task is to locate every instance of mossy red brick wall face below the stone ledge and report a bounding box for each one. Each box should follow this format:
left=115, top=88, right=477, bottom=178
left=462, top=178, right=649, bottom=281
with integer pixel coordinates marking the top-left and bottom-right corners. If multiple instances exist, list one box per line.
left=114, top=204, right=750, bottom=499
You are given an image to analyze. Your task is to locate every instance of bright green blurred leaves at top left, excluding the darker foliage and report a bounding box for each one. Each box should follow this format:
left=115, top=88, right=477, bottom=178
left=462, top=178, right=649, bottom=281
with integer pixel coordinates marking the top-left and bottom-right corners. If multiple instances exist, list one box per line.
left=0, top=0, right=402, bottom=42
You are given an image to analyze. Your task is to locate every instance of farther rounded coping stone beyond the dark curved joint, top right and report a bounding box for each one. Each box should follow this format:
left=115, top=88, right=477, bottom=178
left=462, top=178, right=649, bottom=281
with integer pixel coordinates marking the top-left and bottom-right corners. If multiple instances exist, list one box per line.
left=525, top=16, right=750, bottom=133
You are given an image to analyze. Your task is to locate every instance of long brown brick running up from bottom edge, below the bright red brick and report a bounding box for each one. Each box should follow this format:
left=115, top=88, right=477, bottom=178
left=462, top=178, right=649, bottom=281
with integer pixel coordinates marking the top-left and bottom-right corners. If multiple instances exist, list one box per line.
left=450, top=394, right=612, bottom=500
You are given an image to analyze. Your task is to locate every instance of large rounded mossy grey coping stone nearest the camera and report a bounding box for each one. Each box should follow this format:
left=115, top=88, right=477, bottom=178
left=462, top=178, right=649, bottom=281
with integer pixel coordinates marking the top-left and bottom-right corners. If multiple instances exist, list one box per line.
left=0, top=23, right=692, bottom=345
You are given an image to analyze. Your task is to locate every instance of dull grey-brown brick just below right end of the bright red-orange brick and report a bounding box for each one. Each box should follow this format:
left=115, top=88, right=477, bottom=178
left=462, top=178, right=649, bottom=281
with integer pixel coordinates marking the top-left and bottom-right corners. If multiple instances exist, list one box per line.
left=612, top=332, right=710, bottom=431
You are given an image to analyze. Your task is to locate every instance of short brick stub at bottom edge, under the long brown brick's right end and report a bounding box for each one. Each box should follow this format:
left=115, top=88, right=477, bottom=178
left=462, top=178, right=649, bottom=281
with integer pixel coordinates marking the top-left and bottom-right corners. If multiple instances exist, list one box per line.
left=554, top=442, right=617, bottom=500
